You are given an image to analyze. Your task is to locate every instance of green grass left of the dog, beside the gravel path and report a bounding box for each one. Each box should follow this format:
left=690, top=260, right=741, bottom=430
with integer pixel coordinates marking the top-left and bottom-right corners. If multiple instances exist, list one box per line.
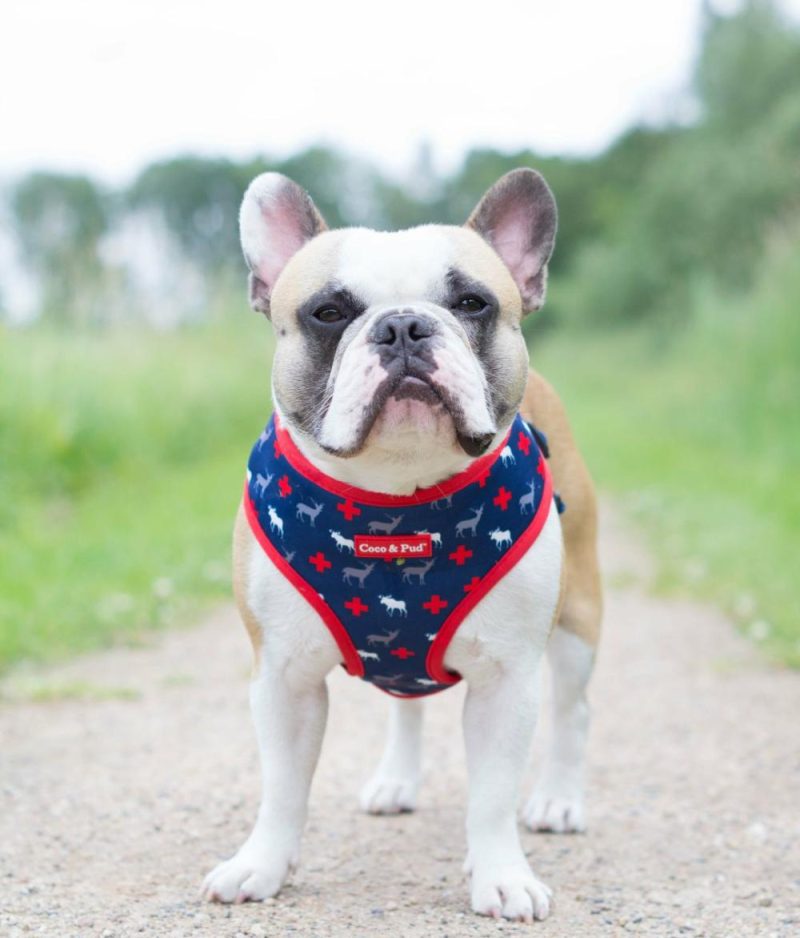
left=0, top=312, right=270, bottom=669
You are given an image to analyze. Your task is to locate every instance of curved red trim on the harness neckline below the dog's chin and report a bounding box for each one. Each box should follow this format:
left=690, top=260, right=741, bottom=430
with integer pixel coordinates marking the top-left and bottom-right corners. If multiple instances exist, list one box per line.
left=275, top=413, right=511, bottom=508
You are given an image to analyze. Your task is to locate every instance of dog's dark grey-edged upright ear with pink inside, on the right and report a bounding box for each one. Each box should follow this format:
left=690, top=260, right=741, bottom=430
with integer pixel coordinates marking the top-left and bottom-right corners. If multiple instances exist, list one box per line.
left=467, top=169, right=558, bottom=313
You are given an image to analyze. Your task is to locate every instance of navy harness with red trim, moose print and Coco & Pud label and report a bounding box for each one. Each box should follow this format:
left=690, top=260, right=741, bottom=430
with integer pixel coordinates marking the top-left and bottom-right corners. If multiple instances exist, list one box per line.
left=244, top=415, right=553, bottom=697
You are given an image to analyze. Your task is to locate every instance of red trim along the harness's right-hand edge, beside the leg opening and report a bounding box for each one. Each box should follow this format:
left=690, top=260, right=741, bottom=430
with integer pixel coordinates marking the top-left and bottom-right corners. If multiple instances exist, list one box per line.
left=425, top=456, right=553, bottom=684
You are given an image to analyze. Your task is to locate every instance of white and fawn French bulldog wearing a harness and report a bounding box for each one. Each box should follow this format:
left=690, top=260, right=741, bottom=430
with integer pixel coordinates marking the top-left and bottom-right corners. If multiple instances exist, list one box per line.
left=203, top=169, right=602, bottom=922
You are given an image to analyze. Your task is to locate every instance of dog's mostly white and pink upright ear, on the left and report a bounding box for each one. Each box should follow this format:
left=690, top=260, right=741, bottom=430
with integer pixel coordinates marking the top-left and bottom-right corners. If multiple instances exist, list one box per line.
left=239, top=173, right=327, bottom=316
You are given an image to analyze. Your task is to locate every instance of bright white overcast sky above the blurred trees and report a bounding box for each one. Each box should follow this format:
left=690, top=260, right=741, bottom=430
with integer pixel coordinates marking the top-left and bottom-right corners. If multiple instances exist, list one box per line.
left=0, top=0, right=800, bottom=182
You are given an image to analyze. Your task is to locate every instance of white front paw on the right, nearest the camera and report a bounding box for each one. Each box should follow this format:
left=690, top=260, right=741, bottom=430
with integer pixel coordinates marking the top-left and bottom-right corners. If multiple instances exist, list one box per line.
left=470, top=858, right=553, bottom=924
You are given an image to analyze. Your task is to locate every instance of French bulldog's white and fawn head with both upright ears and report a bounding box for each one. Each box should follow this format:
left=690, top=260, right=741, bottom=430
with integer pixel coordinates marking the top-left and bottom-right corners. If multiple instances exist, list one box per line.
left=240, top=169, right=556, bottom=458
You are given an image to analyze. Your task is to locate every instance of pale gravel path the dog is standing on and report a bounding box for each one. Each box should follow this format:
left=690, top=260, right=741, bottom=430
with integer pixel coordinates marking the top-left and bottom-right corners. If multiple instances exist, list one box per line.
left=0, top=504, right=800, bottom=938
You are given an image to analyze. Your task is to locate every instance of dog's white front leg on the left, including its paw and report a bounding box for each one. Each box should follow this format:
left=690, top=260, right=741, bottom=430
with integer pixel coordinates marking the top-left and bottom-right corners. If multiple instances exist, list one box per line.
left=203, top=649, right=328, bottom=902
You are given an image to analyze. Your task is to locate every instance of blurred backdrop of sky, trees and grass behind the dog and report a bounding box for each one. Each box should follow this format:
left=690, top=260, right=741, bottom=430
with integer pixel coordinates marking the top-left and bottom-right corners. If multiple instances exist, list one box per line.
left=0, top=0, right=800, bottom=669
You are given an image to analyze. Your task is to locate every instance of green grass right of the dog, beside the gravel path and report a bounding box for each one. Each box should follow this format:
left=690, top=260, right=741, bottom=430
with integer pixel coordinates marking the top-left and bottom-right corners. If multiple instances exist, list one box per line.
left=534, top=230, right=800, bottom=667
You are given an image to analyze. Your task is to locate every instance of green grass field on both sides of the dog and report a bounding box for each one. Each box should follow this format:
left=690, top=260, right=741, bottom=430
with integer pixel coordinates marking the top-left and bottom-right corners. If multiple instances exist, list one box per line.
left=0, top=234, right=800, bottom=668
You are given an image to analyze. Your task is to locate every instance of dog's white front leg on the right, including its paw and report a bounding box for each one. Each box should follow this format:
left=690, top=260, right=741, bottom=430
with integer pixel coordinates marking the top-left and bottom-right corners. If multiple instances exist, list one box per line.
left=464, top=650, right=550, bottom=922
